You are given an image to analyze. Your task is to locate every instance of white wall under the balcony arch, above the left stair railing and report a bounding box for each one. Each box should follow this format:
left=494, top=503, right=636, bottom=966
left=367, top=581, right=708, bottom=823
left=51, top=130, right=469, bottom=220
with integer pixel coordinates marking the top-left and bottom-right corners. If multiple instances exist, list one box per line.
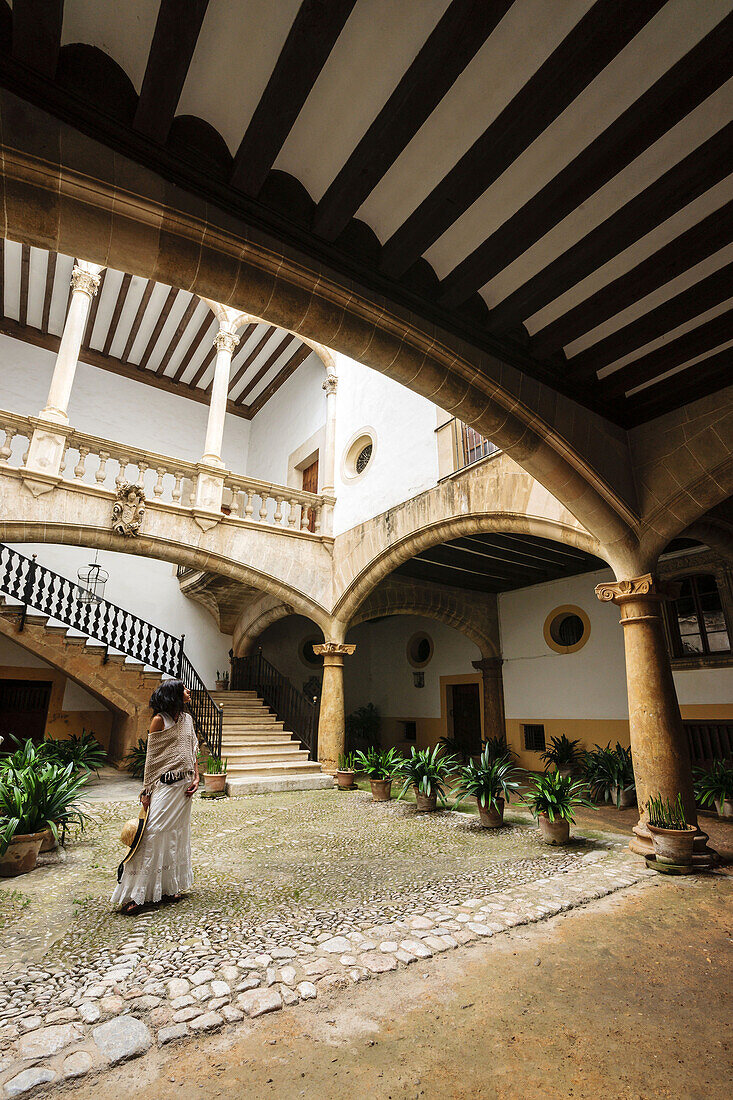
left=7, top=543, right=231, bottom=688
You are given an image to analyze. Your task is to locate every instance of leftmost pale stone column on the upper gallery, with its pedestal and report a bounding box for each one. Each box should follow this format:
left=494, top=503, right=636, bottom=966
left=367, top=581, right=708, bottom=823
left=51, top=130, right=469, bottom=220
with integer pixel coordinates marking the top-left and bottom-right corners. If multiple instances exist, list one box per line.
left=23, top=260, right=102, bottom=496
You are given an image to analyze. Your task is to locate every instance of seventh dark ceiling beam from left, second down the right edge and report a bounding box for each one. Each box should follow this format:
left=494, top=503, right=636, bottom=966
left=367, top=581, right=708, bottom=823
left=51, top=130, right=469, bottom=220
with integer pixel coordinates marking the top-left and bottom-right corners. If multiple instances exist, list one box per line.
left=489, top=122, right=733, bottom=332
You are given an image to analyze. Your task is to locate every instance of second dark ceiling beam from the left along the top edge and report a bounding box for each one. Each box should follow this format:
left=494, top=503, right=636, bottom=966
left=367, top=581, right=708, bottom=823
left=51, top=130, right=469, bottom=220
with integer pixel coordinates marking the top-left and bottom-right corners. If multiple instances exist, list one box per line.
left=133, top=0, right=209, bottom=144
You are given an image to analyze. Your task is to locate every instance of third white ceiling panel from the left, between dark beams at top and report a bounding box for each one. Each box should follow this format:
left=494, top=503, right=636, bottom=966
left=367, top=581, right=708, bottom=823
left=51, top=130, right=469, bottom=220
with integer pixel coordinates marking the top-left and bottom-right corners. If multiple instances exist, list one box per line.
left=274, top=0, right=448, bottom=202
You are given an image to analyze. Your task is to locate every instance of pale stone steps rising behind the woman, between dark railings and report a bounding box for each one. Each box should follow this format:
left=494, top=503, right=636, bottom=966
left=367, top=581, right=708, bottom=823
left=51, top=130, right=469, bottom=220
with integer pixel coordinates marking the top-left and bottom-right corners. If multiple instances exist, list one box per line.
left=211, top=691, right=333, bottom=798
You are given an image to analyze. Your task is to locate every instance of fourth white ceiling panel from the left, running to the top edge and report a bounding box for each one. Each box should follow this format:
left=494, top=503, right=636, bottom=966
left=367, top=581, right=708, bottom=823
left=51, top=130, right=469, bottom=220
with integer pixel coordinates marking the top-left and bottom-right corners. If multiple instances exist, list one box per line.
left=357, top=0, right=593, bottom=242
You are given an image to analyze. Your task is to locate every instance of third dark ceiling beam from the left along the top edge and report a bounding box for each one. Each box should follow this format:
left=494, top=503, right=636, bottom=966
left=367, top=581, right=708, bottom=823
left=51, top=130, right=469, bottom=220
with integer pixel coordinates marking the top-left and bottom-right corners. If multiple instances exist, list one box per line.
left=231, top=0, right=355, bottom=196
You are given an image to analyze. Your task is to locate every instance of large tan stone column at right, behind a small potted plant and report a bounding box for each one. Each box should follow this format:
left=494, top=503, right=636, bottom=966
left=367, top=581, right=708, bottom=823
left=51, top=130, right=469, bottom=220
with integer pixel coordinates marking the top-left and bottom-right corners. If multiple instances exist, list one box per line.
left=595, top=573, right=707, bottom=856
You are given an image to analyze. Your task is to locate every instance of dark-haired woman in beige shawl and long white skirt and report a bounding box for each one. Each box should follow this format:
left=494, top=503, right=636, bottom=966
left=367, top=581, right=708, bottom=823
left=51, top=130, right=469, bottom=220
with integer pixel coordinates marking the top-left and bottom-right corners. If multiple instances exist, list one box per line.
left=112, top=680, right=198, bottom=915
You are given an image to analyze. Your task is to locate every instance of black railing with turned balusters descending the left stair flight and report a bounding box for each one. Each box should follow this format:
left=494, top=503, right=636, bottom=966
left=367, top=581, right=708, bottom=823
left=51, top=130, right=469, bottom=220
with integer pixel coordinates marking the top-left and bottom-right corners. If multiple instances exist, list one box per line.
left=0, top=543, right=221, bottom=756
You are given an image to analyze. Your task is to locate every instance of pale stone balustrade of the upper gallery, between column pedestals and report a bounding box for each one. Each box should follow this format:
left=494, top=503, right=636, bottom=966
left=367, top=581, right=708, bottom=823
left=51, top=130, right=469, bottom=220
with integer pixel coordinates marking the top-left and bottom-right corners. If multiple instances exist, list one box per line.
left=0, top=410, right=333, bottom=537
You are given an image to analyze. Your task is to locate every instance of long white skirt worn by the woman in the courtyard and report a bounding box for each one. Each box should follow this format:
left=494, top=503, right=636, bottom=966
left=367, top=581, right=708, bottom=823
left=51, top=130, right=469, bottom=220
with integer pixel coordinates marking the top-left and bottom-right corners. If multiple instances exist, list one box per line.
left=112, top=779, right=194, bottom=909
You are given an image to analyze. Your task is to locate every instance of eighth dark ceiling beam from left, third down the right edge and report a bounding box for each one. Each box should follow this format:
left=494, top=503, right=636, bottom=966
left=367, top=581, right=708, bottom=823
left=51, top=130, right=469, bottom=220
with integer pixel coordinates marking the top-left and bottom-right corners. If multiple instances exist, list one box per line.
left=532, top=199, right=733, bottom=355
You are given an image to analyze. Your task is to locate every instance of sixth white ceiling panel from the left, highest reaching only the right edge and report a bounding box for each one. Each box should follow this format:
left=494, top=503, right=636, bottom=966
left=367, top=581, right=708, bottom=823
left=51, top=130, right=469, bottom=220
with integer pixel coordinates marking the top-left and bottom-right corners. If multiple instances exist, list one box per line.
left=481, top=79, right=733, bottom=306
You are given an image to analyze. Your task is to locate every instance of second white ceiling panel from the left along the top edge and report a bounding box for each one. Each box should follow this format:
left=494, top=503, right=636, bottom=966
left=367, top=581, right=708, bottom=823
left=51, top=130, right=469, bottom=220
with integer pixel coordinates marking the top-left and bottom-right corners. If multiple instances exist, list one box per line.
left=176, top=0, right=300, bottom=155
